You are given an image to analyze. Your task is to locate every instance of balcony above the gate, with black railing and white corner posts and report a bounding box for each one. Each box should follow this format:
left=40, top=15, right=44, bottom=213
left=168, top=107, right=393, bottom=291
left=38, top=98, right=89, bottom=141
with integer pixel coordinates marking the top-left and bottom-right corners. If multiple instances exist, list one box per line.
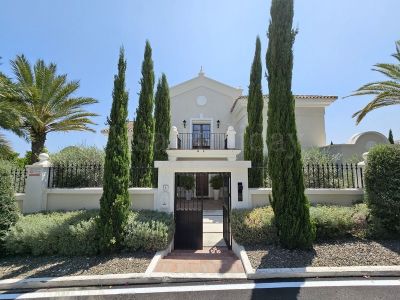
left=167, top=126, right=240, bottom=161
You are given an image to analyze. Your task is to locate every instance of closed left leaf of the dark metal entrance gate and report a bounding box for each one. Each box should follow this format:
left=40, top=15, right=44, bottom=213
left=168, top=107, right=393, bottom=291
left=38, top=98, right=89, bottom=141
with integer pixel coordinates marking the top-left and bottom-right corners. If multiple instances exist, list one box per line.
left=174, top=173, right=203, bottom=250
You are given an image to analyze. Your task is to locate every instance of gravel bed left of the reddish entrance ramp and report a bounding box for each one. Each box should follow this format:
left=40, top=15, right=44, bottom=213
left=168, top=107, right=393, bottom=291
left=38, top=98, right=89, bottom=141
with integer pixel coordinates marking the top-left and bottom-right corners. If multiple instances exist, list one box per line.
left=0, top=253, right=154, bottom=279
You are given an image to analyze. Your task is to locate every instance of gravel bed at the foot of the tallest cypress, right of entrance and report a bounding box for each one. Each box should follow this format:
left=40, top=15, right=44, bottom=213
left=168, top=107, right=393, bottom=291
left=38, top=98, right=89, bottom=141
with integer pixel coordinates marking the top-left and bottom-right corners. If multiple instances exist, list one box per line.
left=246, top=239, right=400, bottom=269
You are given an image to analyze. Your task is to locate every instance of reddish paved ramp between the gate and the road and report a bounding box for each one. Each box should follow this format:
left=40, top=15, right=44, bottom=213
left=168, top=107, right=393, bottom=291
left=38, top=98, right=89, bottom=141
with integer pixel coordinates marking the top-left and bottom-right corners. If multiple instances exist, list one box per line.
left=154, top=247, right=244, bottom=273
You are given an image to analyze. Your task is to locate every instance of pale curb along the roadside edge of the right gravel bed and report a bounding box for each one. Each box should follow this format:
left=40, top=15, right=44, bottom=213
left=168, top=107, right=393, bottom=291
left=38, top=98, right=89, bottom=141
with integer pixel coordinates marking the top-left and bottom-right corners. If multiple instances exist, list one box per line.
left=247, top=266, right=400, bottom=279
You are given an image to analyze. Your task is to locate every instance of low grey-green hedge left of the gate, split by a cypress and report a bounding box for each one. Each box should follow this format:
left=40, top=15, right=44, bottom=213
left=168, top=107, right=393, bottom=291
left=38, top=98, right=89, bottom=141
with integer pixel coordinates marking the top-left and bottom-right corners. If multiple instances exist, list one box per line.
left=5, top=211, right=174, bottom=256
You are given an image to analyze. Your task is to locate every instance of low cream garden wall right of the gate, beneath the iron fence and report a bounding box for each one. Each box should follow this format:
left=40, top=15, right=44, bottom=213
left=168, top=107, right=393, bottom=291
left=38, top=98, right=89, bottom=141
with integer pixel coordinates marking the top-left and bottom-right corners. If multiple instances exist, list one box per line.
left=249, top=188, right=364, bottom=207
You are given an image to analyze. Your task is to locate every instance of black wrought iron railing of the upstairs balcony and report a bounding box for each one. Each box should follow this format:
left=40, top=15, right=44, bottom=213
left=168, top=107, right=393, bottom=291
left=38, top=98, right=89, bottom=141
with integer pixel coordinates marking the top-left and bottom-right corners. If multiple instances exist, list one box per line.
left=178, top=132, right=227, bottom=150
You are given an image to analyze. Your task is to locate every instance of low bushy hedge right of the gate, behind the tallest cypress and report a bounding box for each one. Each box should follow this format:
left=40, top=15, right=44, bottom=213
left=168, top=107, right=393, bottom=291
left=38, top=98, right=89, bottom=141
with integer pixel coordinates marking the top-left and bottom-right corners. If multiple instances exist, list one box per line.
left=231, top=204, right=369, bottom=245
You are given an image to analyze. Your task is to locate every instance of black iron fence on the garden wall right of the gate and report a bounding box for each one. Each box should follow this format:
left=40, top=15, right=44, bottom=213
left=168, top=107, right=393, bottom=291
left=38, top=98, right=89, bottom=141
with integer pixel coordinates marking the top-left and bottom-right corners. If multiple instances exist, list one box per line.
left=249, top=164, right=364, bottom=189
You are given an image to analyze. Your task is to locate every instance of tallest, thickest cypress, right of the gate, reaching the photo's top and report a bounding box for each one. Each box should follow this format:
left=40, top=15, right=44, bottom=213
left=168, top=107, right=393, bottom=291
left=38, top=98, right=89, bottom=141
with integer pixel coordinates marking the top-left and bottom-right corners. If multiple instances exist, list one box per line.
left=266, top=0, right=315, bottom=249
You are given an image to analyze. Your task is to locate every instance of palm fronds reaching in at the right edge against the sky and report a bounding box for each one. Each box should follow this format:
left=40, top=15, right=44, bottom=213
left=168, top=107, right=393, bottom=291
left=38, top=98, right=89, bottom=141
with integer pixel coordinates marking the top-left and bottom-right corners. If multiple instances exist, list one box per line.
left=349, top=41, right=400, bottom=124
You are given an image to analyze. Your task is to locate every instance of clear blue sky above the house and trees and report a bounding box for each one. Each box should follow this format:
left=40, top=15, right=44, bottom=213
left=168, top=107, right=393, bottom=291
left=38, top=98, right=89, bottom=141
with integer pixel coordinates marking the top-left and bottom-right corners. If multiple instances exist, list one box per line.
left=0, top=0, right=400, bottom=155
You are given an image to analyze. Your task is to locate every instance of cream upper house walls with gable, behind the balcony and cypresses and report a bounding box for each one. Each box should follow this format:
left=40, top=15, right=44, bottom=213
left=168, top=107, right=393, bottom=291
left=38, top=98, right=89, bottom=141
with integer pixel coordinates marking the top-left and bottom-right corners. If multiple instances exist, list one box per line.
left=170, top=72, right=337, bottom=158
